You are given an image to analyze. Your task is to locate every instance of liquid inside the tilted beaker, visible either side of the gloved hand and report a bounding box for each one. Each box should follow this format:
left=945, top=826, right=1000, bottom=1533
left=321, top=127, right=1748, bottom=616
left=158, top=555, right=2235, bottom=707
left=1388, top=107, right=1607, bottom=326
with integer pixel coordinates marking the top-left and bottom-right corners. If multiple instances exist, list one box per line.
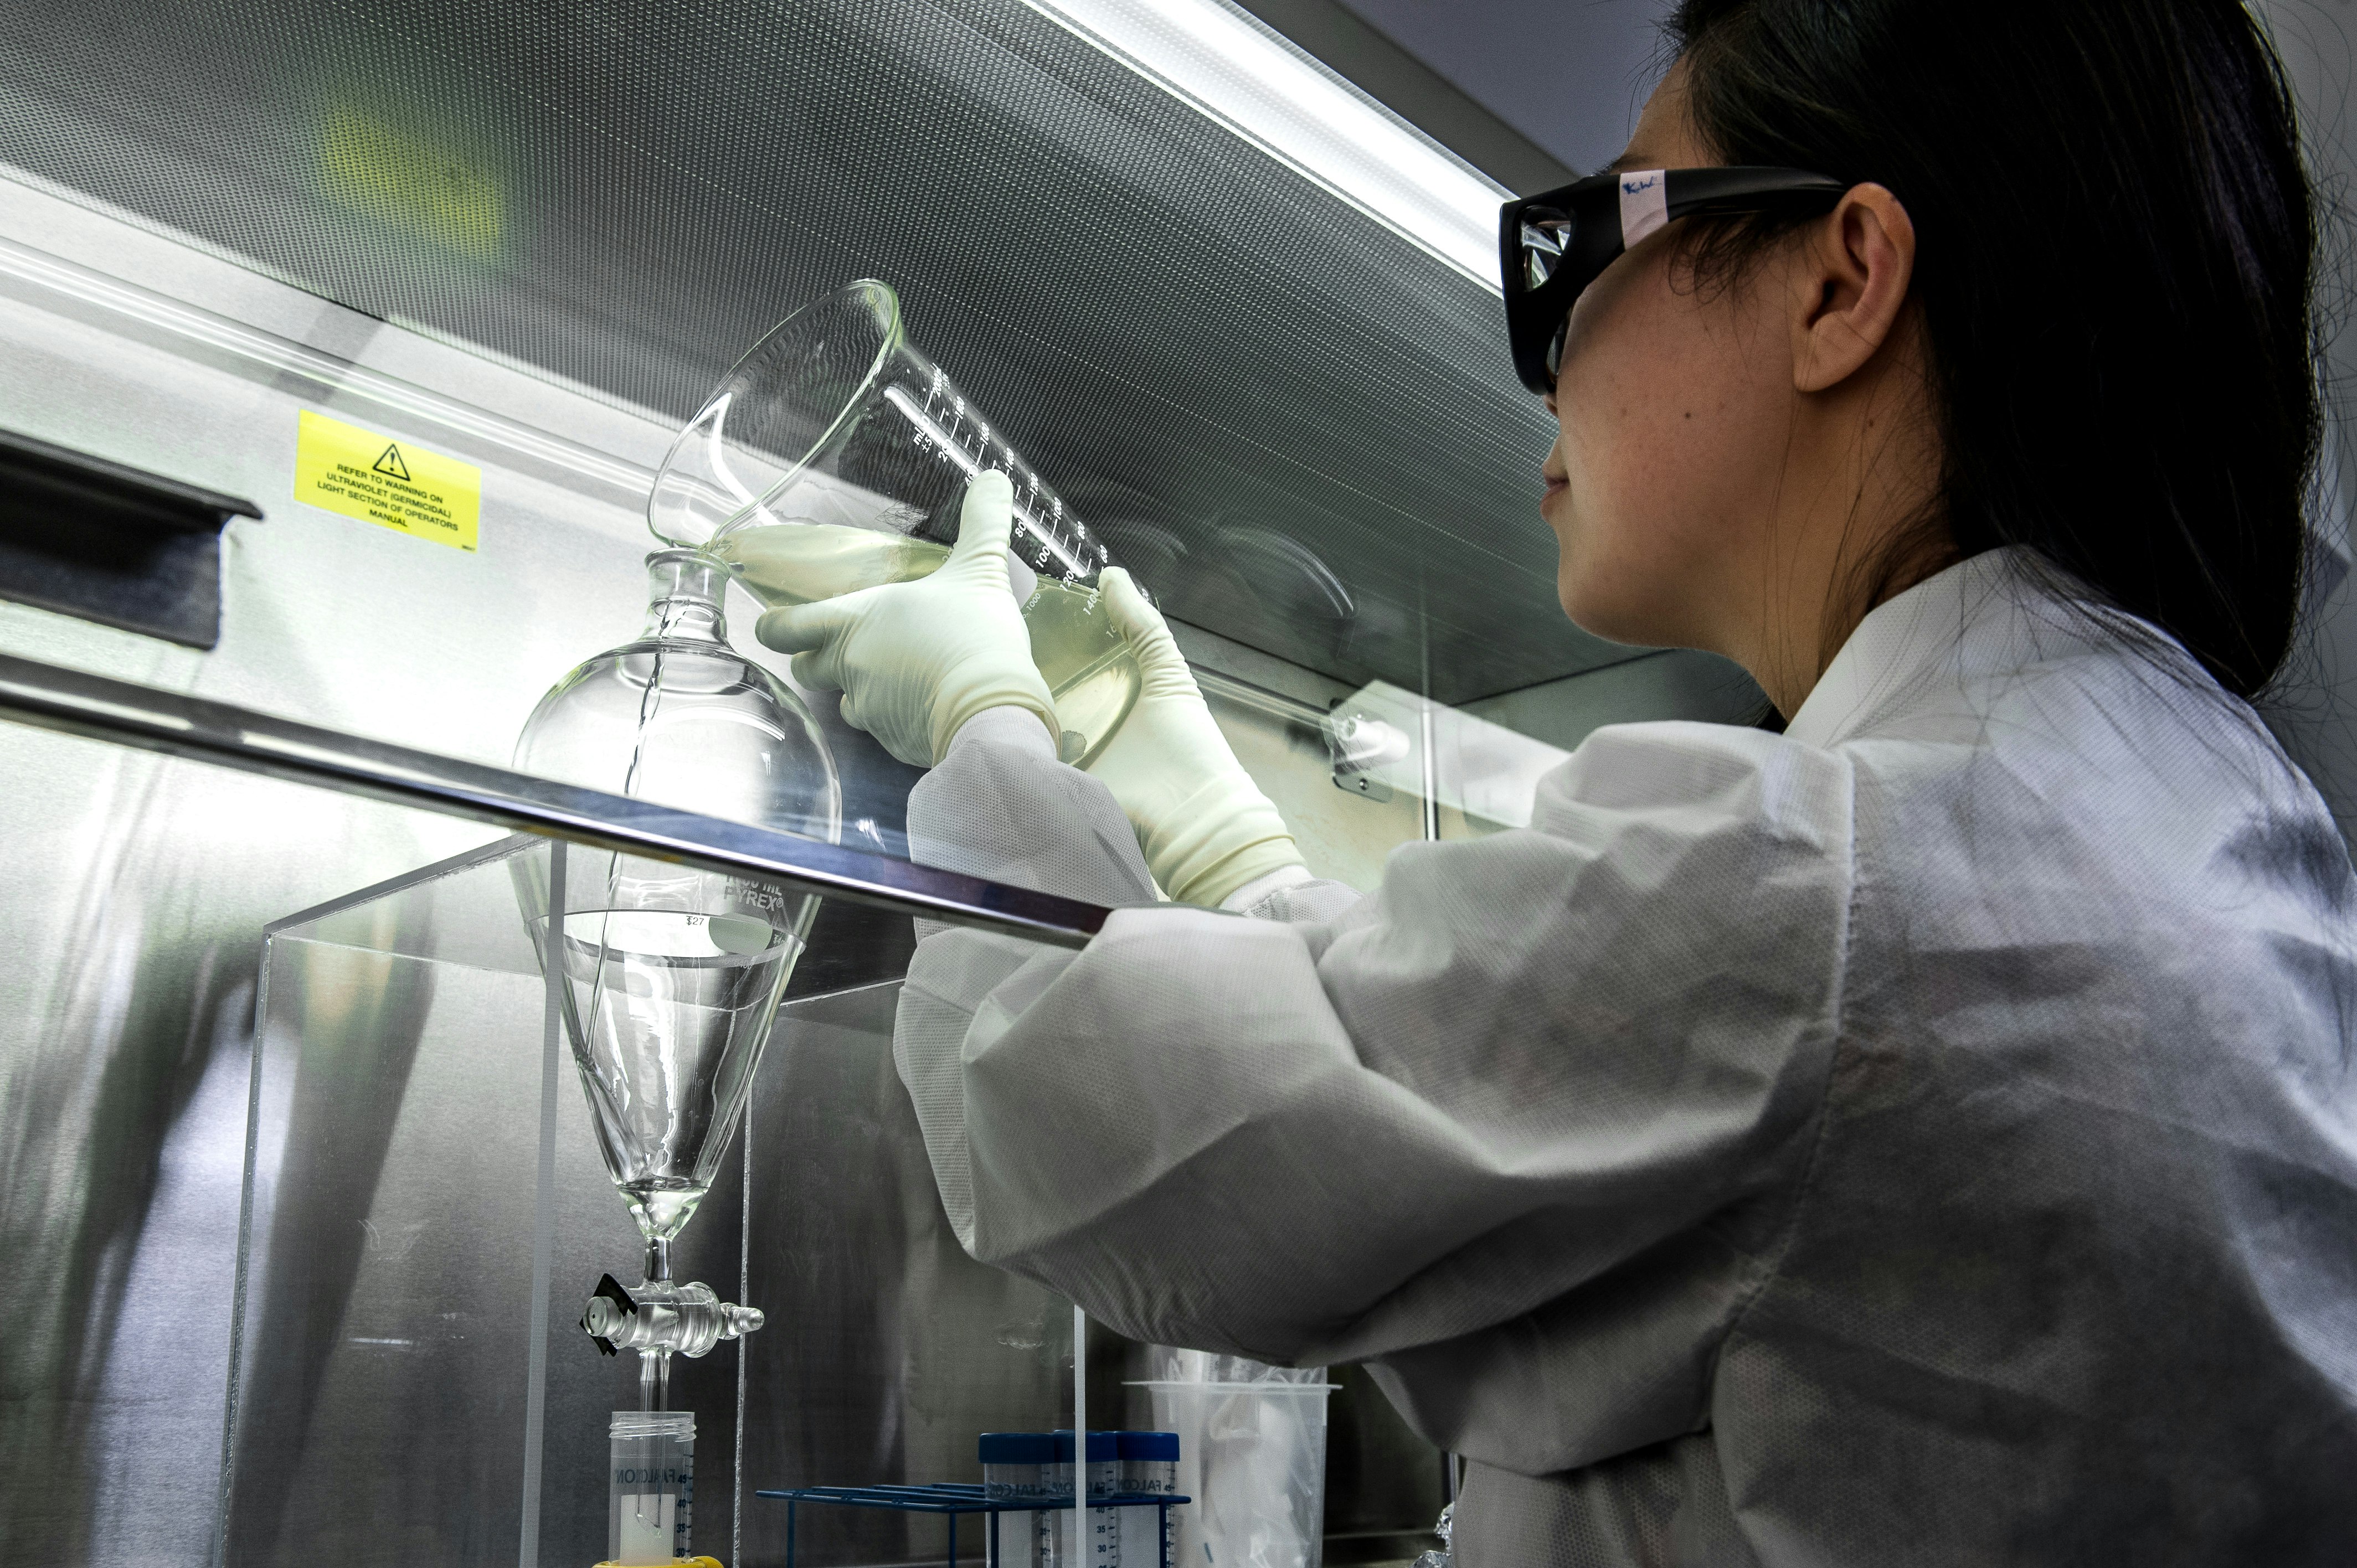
left=714, top=523, right=1141, bottom=764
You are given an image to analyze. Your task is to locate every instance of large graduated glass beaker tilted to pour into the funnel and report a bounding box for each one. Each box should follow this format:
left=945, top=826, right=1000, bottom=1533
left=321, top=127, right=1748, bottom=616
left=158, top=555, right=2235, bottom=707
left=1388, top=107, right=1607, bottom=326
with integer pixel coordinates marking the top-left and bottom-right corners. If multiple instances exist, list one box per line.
left=646, top=278, right=1139, bottom=764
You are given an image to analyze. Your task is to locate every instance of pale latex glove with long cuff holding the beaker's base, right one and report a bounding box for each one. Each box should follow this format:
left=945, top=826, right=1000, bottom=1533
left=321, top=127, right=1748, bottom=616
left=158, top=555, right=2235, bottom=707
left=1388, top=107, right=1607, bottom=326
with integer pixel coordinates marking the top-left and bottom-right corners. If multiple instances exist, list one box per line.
left=1089, top=566, right=1301, bottom=908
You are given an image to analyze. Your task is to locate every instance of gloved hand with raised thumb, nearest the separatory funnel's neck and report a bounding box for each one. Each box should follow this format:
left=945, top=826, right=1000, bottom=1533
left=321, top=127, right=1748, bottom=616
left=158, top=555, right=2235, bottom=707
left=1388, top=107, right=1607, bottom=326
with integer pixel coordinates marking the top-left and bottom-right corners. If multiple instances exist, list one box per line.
left=752, top=474, right=1061, bottom=768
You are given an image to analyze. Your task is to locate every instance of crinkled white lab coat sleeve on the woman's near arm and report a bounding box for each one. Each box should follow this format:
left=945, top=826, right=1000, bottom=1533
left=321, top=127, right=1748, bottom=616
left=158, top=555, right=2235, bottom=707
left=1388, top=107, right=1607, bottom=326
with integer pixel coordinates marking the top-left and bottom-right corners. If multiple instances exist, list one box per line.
left=896, top=724, right=1850, bottom=1396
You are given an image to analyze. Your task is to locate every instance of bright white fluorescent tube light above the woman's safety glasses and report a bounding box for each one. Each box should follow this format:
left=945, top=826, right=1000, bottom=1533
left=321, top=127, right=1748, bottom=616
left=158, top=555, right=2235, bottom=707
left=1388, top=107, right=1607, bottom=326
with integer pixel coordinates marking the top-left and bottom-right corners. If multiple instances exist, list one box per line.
left=1025, top=0, right=1513, bottom=288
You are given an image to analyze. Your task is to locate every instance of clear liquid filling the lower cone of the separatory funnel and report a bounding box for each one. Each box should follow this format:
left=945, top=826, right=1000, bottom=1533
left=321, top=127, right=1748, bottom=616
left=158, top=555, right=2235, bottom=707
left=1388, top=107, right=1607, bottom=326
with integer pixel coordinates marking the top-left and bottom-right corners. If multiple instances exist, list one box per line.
left=544, top=910, right=801, bottom=1236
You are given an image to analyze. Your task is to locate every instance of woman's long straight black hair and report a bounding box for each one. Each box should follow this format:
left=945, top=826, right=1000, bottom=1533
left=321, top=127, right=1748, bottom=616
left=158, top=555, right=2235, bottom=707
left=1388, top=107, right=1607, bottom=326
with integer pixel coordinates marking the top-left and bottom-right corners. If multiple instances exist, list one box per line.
left=1671, top=0, right=2322, bottom=695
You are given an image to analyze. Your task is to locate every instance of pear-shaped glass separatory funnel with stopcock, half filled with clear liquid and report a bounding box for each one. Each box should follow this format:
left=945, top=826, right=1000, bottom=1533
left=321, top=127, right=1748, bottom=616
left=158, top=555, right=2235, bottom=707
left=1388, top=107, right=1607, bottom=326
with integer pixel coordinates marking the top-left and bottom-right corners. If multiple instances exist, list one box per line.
left=514, top=549, right=841, bottom=1410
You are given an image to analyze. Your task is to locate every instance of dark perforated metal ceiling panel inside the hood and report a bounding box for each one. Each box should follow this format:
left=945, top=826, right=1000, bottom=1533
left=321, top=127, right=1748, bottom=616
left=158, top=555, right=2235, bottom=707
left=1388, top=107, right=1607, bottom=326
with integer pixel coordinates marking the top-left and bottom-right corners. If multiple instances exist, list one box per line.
left=0, top=0, right=1622, bottom=703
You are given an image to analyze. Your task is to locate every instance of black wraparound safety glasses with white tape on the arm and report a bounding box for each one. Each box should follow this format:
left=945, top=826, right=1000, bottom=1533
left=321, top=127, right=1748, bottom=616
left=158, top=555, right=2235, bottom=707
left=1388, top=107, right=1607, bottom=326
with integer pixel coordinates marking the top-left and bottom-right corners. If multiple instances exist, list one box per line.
left=1497, top=167, right=1850, bottom=399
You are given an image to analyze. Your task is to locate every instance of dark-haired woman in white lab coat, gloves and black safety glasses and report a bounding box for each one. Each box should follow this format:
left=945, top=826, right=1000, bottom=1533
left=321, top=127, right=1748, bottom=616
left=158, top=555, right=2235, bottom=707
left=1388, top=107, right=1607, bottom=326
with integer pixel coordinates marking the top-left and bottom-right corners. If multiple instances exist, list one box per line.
left=759, top=0, right=2357, bottom=1568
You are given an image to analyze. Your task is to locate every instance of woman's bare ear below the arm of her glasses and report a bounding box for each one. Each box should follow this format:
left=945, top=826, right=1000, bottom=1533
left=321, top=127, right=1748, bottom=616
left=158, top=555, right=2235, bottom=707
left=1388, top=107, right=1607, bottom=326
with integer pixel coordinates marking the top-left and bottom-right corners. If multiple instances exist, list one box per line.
left=1792, top=184, right=1914, bottom=391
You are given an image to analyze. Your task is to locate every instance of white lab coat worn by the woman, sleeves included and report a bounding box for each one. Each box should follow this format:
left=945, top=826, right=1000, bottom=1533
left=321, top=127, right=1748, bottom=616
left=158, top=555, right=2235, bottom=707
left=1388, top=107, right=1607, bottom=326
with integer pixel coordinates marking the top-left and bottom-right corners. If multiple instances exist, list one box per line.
left=896, top=554, right=2357, bottom=1568
